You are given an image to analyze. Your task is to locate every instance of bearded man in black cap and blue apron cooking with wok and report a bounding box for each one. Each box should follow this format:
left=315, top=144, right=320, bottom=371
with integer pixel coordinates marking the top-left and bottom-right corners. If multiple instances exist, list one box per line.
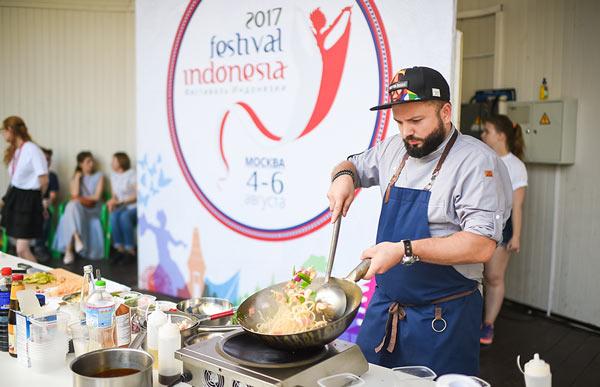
left=327, top=67, right=512, bottom=375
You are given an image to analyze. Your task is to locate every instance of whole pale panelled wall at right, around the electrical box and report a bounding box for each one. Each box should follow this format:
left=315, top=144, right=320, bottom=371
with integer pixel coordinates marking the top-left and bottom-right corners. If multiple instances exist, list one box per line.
left=458, top=0, right=600, bottom=325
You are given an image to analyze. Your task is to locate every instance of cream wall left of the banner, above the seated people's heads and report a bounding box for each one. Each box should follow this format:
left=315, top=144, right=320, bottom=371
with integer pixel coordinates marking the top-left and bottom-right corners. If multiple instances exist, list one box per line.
left=0, top=0, right=135, bottom=199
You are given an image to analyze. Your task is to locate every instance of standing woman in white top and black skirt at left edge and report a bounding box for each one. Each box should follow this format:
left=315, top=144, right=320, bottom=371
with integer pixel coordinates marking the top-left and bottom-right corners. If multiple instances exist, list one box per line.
left=2, top=116, right=48, bottom=262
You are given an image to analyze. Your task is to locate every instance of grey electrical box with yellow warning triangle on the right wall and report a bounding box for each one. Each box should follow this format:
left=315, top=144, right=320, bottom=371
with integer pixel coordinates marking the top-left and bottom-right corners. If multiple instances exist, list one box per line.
left=507, top=100, right=577, bottom=164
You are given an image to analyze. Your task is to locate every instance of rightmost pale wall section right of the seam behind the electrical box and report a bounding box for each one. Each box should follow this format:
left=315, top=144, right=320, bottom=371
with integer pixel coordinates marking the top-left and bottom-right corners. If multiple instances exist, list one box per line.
left=553, top=0, right=600, bottom=325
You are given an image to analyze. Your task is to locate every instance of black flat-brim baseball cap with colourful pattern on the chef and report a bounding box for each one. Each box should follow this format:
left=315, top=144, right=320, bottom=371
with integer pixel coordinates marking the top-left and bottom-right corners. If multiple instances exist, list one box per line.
left=370, top=66, right=450, bottom=110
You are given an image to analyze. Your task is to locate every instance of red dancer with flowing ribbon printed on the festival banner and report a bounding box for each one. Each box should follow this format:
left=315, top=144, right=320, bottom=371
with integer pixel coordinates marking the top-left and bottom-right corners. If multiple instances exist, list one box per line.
left=219, top=7, right=352, bottom=171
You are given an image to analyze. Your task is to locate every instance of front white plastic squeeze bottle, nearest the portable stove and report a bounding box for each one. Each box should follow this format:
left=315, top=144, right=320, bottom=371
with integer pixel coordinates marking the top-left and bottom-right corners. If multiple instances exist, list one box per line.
left=158, top=315, right=183, bottom=385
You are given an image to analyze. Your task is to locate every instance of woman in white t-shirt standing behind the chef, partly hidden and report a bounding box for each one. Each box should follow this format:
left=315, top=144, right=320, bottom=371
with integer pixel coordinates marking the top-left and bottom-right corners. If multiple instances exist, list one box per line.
left=480, top=115, right=527, bottom=345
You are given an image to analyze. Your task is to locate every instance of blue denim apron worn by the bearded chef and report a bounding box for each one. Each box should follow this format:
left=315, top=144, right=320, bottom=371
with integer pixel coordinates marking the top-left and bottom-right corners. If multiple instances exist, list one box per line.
left=357, top=131, right=483, bottom=375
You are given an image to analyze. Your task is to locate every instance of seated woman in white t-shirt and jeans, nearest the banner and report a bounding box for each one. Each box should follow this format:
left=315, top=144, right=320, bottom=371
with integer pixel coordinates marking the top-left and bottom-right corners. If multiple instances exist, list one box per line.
left=106, top=152, right=137, bottom=262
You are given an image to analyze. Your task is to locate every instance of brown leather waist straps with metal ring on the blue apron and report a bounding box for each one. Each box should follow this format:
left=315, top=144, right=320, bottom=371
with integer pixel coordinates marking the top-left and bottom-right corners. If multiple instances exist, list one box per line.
left=375, top=288, right=477, bottom=353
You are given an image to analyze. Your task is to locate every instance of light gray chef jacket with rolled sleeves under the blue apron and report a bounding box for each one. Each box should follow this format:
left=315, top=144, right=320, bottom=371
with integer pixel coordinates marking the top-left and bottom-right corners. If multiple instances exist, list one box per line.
left=348, top=127, right=512, bottom=283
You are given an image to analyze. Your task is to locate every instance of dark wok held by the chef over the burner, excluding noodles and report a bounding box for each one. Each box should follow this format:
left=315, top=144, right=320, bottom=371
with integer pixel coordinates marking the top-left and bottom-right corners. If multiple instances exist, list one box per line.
left=237, top=259, right=371, bottom=350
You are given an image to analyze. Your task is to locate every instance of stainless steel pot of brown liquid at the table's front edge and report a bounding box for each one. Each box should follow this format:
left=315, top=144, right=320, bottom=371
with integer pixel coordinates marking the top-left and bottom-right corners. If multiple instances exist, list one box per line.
left=70, top=348, right=153, bottom=387
